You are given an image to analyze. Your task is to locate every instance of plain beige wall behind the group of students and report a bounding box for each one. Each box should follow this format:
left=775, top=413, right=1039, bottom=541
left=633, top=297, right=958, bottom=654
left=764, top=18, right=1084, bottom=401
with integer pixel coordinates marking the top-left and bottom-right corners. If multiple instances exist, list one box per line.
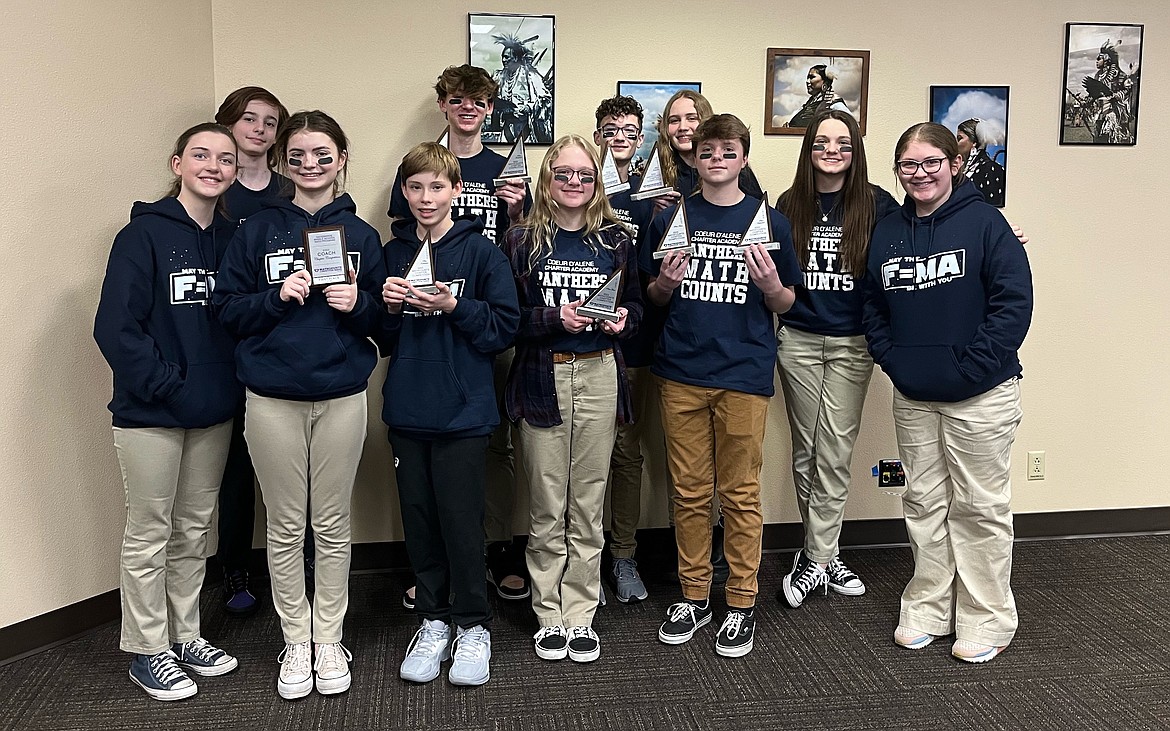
left=0, top=0, right=1170, bottom=626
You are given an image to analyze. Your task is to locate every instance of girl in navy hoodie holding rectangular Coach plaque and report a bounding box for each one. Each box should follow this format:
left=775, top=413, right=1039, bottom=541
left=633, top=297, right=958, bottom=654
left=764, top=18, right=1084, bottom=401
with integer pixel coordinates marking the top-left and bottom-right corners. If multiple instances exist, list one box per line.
left=214, top=111, right=386, bottom=698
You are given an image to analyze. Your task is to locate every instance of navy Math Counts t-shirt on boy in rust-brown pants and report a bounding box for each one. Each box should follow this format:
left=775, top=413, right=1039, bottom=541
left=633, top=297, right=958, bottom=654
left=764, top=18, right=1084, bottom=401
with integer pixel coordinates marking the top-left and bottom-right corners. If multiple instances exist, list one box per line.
left=639, top=194, right=800, bottom=396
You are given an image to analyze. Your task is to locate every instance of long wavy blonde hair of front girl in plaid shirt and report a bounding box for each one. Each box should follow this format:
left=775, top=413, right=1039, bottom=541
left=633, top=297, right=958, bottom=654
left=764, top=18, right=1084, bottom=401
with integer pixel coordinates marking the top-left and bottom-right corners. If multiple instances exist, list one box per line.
left=516, top=135, right=625, bottom=274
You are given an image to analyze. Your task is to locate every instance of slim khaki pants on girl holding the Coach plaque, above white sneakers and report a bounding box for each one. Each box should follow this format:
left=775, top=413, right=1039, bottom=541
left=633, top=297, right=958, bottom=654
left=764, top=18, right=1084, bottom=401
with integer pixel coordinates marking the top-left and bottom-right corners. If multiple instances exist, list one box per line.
left=245, top=391, right=366, bottom=643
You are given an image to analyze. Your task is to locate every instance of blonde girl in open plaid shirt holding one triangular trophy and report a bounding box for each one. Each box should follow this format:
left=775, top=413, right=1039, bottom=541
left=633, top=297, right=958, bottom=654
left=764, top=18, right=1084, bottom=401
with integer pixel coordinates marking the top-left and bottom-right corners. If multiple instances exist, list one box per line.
left=504, top=136, right=641, bottom=662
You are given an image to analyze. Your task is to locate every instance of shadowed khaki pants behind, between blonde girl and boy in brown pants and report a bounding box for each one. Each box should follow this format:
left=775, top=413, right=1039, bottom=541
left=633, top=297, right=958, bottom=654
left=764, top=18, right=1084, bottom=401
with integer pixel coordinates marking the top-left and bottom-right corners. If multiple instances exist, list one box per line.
left=610, top=368, right=656, bottom=558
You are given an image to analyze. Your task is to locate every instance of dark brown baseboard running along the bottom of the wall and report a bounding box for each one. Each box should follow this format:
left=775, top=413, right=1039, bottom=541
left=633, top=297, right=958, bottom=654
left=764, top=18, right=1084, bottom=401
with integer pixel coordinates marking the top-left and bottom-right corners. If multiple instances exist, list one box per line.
left=0, top=505, right=1170, bottom=666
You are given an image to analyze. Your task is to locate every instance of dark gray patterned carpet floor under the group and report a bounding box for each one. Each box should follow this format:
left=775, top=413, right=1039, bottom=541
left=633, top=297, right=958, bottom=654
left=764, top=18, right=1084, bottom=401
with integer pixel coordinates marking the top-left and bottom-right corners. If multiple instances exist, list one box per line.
left=0, top=536, right=1170, bottom=731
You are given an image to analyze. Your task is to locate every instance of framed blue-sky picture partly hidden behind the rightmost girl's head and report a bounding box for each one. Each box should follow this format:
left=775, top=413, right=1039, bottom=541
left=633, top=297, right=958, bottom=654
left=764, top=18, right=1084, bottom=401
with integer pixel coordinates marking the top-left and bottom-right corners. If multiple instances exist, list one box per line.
left=930, top=87, right=1007, bottom=208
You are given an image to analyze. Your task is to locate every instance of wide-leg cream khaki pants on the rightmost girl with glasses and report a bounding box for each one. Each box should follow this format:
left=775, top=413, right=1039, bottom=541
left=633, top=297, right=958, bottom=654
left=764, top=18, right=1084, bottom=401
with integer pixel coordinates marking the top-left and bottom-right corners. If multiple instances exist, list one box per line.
left=894, top=378, right=1023, bottom=647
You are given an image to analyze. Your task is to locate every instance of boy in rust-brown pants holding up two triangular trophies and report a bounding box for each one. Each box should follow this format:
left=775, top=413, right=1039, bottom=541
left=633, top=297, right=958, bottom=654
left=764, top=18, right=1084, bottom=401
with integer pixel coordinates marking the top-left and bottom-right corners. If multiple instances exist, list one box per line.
left=640, top=115, right=800, bottom=657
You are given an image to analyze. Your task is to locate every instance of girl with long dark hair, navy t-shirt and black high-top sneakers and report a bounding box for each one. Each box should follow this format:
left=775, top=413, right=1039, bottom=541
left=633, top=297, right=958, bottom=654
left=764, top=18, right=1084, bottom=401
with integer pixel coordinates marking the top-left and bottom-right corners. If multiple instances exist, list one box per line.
left=776, top=110, right=897, bottom=607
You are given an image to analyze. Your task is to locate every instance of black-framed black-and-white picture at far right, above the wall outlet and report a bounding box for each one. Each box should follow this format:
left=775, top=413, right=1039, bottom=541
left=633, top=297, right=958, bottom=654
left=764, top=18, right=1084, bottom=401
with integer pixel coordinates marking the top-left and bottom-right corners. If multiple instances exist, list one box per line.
left=1060, top=23, right=1145, bottom=145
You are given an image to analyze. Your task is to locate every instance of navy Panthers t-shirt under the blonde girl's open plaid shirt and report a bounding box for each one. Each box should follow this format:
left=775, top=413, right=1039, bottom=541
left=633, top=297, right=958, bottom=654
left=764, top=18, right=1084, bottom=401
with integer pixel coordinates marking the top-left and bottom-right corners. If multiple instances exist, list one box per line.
left=532, top=230, right=614, bottom=353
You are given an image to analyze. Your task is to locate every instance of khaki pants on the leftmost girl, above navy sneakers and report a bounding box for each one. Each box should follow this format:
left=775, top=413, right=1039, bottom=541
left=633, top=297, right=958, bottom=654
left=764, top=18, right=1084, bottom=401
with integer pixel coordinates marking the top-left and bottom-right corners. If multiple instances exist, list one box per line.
left=113, top=421, right=232, bottom=655
